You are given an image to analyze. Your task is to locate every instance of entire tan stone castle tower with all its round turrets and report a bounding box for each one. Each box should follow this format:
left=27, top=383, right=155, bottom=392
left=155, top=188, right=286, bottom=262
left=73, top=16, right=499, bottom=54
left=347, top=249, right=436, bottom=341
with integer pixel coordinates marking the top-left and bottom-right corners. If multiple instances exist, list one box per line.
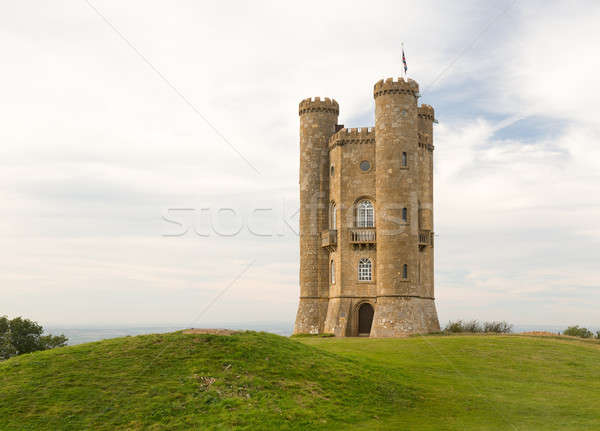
left=294, top=78, right=439, bottom=337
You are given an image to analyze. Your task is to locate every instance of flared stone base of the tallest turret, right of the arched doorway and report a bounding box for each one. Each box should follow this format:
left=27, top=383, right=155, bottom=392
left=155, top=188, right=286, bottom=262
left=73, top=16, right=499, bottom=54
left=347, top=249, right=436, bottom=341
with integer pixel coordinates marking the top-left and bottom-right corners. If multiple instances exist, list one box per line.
left=371, top=296, right=440, bottom=337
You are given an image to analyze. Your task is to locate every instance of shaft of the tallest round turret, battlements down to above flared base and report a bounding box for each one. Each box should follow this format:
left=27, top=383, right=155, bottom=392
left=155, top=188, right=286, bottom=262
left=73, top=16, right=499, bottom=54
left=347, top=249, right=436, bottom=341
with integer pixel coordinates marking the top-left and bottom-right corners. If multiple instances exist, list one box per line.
left=374, top=78, right=419, bottom=308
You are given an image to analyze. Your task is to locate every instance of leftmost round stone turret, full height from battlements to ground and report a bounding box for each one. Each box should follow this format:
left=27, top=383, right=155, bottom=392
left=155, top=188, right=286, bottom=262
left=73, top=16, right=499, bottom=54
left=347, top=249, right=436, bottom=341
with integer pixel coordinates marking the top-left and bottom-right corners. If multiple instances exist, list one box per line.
left=294, top=97, right=339, bottom=334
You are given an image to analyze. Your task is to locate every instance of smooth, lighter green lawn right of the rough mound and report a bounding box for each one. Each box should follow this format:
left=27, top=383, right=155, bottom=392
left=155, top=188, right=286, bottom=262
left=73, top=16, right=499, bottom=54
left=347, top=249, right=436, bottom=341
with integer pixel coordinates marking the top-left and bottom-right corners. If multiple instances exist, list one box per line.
left=306, top=335, right=600, bottom=431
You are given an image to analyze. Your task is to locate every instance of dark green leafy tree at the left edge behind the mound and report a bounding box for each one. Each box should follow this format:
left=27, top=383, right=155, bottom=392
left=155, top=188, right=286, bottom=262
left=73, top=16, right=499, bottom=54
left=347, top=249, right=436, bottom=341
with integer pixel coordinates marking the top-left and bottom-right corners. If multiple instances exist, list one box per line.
left=0, top=316, right=68, bottom=360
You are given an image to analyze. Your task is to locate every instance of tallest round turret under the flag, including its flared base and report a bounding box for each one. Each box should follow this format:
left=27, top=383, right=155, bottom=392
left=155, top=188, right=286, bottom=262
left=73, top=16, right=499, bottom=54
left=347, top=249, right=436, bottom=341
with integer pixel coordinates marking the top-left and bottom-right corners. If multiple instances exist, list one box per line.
left=371, top=78, right=437, bottom=337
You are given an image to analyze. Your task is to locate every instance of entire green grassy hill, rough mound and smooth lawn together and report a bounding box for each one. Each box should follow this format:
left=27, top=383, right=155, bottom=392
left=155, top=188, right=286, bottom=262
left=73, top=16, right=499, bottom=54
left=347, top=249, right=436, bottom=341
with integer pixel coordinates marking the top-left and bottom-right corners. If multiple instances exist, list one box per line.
left=0, top=332, right=600, bottom=431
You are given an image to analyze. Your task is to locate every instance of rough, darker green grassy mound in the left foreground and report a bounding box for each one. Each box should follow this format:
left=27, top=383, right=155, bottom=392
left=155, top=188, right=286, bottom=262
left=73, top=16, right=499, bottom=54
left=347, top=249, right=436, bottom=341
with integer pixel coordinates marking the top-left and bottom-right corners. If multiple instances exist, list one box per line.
left=0, top=332, right=411, bottom=430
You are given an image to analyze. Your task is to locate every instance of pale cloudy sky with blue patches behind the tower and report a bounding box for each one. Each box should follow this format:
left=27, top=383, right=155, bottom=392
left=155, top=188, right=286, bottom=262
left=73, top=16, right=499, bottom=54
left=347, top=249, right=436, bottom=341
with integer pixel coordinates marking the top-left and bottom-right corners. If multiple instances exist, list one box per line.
left=0, top=0, right=600, bottom=326
